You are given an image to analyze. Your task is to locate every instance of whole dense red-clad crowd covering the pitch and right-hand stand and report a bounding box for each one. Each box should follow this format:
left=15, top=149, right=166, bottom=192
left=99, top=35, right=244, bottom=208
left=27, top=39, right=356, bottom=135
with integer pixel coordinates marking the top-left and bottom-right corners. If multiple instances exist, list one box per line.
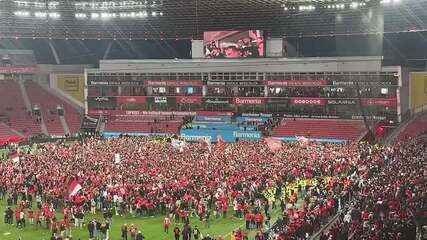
left=0, top=137, right=425, bottom=240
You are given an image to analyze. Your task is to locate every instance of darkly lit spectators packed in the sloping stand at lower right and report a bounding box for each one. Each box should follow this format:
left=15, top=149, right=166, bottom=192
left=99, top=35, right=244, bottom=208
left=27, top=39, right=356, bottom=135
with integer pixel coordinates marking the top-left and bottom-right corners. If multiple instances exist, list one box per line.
left=320, top=140, right=427, bottom=240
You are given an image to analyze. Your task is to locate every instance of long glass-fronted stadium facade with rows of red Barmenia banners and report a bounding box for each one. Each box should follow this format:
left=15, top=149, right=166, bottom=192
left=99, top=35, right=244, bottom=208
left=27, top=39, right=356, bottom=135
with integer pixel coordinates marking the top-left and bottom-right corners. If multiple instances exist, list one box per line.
left=85, top=57, right=409, bottom=122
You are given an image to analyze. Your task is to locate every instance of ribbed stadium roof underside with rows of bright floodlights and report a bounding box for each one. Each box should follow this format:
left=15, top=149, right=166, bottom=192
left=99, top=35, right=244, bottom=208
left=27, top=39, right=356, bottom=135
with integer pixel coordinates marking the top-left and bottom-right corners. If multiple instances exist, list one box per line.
left=0, top=0, right=427, bottom=39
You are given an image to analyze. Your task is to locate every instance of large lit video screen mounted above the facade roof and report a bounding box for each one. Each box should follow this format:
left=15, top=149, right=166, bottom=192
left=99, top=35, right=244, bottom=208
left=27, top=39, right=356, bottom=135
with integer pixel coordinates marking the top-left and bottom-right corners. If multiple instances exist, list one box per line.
left=203, top=30, right=265, bottom=58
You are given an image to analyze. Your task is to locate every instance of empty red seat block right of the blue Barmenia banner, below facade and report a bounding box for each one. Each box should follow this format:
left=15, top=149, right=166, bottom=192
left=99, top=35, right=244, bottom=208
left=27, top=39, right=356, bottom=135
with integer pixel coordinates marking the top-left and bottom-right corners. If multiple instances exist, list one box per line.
left=273, top=119, right=365, bottom=140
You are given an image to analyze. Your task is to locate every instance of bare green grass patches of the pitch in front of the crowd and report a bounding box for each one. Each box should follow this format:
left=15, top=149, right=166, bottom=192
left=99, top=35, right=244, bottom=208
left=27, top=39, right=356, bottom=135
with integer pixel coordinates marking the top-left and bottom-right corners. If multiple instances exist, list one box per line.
left=0, top=202, right=252, bottom=240
